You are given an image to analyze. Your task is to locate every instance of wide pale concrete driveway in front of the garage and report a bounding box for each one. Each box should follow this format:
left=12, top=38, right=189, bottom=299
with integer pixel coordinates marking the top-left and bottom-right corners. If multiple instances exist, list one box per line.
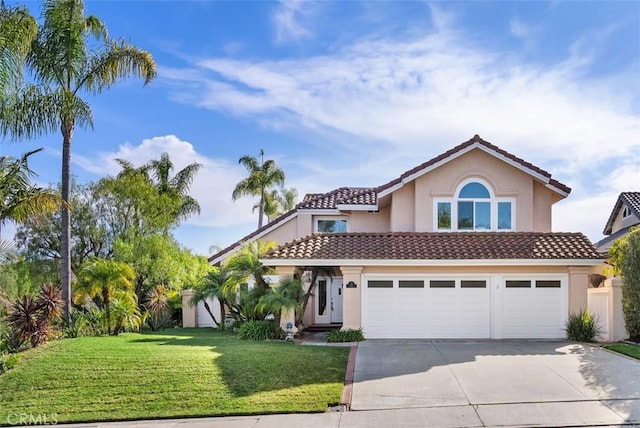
left=351, top=340, right=640, bottom=426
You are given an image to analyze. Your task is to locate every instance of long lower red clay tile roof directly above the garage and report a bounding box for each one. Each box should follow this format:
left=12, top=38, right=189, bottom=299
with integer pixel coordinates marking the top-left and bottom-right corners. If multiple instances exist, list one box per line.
left=264, top=232, right=601, bottom=260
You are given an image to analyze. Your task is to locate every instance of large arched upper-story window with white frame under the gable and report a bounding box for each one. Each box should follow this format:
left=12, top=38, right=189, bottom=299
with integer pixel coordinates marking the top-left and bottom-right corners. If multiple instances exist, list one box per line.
left=434, top=180, right=515, bottom=231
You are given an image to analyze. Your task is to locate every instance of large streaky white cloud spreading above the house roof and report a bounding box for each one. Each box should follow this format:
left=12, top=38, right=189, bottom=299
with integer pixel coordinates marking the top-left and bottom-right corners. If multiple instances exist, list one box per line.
left=164, top=5, right=640, bottom=244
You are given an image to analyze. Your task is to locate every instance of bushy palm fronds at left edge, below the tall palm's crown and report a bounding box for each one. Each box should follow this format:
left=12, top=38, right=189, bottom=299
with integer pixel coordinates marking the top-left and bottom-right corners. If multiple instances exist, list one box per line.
left=0, top=149, right=62, bottom=239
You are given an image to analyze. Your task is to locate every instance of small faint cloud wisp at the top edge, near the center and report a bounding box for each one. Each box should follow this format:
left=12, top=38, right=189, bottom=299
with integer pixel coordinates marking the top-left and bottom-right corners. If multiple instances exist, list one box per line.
left=272, top=0, right=313, bottom=43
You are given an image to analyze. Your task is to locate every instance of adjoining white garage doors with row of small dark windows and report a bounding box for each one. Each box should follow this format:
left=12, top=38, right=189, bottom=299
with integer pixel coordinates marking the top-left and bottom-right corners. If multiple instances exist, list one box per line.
left=362, top=274, right=568, bottom=339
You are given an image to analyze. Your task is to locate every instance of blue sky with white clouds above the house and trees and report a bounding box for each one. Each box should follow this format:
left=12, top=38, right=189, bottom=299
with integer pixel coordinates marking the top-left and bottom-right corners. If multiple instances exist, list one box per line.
left=0, top=0, right=640, bottom=254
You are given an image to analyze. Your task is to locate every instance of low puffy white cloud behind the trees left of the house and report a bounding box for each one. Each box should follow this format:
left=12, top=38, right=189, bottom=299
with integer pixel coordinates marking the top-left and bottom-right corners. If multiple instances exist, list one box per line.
left=74, top=135, right=257, bottom=231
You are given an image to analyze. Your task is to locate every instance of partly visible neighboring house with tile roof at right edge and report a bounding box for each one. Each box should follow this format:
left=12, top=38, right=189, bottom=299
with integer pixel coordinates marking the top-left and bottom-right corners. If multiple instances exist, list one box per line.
left=596, top=192, right=640, bottom=253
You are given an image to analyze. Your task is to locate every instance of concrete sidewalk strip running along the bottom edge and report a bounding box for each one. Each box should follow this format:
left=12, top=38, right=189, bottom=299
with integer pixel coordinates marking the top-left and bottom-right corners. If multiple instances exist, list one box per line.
left=50, top=401, right=640, bottom=428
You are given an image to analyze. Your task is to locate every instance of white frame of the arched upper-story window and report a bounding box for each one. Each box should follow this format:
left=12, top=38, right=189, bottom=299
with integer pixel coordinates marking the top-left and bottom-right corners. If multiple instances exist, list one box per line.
left=433, top=178, right=516, bottom=232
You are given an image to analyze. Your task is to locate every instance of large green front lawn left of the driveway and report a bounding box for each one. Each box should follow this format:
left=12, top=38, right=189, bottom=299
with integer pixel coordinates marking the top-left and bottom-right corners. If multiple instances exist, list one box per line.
left=0, top=329, right=348, bottom=424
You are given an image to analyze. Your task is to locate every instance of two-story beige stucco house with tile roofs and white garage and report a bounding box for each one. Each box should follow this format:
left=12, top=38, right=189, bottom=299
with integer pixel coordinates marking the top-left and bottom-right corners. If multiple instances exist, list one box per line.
left=199, top=135, right=602, bottom=339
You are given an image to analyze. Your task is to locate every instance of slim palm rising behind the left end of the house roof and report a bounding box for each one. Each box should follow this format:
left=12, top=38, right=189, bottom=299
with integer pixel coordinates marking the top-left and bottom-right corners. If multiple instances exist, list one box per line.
left=231, top=149, right=284, bottom=228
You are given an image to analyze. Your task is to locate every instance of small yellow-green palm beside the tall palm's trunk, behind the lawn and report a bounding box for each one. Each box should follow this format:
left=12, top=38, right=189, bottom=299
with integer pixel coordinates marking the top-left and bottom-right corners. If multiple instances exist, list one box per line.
left=74, top=259, right=136, bottom=334
